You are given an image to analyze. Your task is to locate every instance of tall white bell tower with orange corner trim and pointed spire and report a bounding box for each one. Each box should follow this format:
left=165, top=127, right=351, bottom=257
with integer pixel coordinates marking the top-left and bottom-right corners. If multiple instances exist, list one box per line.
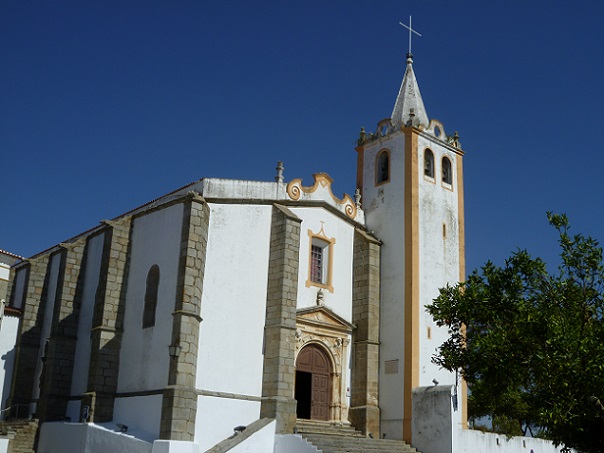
left=356, top=53, right=467, bottom=442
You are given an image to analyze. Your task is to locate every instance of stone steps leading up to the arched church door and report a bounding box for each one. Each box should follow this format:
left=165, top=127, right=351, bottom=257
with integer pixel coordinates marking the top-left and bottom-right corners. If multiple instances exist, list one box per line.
left=296, top=420, right=417, bottom=453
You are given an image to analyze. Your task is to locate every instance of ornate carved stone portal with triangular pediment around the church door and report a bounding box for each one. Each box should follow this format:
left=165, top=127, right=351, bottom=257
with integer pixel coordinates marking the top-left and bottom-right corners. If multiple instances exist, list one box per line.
left=295, top=305, right=353, bottom=424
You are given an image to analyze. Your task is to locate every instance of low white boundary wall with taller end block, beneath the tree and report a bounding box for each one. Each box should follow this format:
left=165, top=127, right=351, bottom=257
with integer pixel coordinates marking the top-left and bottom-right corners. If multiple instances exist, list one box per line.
left=412, top=385, right=562, bottom=453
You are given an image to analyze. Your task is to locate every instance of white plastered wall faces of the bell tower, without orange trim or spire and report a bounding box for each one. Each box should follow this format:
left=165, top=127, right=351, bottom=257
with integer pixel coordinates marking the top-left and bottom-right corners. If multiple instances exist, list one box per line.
left=362, top=125, right=461, bottom=438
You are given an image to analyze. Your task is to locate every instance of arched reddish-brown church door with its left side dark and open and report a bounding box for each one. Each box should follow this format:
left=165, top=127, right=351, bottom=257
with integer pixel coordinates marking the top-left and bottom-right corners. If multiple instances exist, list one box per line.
left=294, top=344, right=332, bottom=420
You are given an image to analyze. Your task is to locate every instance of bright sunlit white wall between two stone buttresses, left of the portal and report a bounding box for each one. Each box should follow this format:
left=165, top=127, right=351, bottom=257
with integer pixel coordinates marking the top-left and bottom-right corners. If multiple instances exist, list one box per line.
left=195, top=203, right=272, bottom=449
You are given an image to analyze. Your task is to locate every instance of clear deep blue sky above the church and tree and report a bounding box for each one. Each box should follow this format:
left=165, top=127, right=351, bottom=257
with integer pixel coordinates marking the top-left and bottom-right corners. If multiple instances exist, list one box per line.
left=0, top=0, right=604, bottom=276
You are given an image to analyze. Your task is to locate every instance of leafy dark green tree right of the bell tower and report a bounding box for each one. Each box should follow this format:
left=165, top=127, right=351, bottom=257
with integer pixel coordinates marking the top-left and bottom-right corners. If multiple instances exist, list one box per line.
left=427, top=213, right=604, bottom=453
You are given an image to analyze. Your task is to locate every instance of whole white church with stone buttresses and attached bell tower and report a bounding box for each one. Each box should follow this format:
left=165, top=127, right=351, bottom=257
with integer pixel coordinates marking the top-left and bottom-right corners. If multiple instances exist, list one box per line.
left=6, top=50, right=466, bottom=453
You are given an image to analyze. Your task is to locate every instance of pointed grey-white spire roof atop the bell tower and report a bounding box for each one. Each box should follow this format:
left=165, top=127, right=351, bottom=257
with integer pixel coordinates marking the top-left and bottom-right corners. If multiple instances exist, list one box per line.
left=391, top=53, right=430, bottom=128
